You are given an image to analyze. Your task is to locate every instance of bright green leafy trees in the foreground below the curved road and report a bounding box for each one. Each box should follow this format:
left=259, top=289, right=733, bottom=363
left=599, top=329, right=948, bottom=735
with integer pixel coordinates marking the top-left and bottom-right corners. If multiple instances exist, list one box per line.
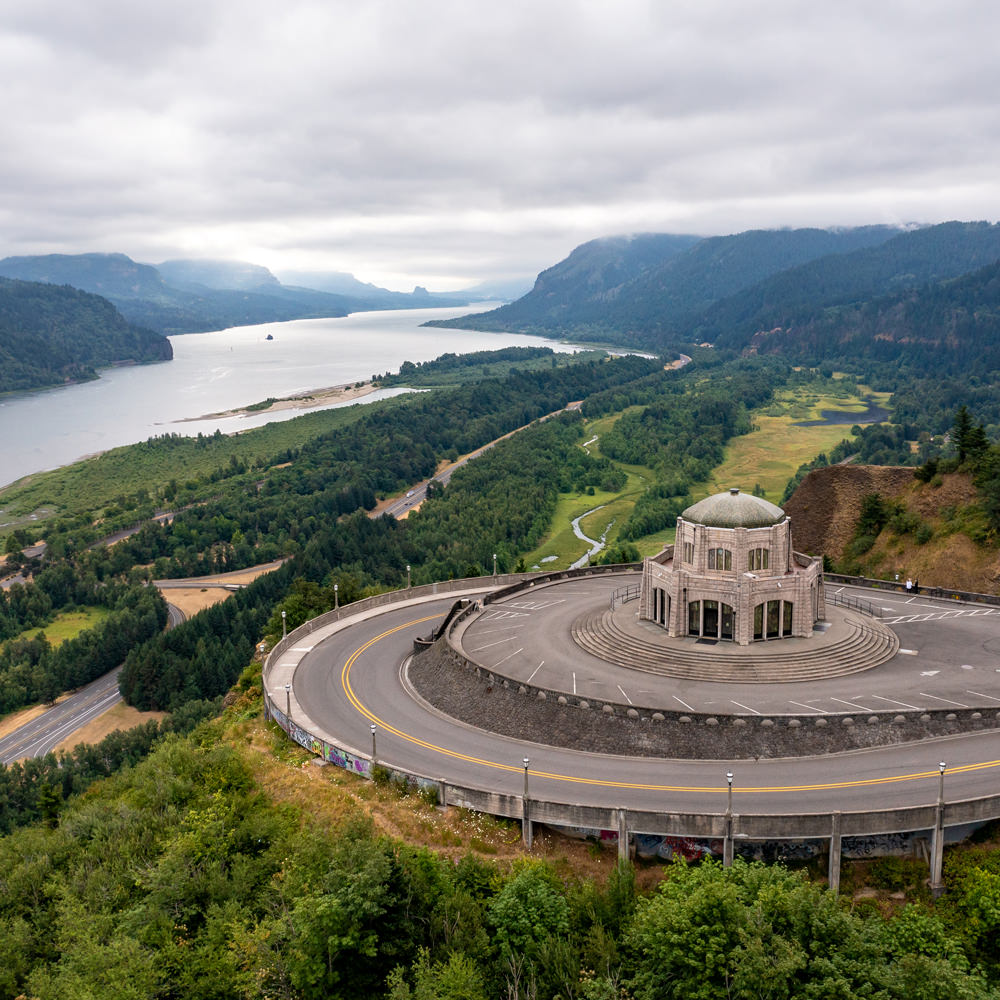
left=0, top=720, right=1000, bottom=1000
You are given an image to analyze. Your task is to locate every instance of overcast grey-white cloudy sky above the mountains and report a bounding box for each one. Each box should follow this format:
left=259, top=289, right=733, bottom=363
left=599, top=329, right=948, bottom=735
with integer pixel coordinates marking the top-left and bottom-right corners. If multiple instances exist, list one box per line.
left=0, top=0, right=1000, bottom=290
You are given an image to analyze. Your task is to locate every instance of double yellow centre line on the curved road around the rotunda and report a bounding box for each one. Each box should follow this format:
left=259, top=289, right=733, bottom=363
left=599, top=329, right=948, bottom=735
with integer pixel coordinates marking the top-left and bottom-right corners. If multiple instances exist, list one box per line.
left=340, top=615, right=1000, bottom=795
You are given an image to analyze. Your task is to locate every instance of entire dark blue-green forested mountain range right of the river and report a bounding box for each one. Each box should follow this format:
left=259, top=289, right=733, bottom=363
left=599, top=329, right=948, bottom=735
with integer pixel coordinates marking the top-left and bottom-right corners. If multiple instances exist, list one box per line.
left=435, top=222, right=1000, bottom=370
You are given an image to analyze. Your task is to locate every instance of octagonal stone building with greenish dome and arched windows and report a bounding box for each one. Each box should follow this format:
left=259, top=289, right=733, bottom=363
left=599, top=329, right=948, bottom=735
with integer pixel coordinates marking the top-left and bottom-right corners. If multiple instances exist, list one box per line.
left=639, top=489, right=825, bottom=646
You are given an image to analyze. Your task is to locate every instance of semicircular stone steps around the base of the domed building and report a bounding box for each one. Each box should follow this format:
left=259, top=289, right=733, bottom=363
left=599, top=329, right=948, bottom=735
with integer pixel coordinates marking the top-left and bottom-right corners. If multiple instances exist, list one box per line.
left=571, top=610, right=899, bottom=684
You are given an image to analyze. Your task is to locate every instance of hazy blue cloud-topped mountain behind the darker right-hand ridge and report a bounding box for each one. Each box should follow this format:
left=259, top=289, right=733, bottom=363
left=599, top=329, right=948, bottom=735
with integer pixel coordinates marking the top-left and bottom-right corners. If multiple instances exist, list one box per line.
left=432, top=226, right=898, bottom=349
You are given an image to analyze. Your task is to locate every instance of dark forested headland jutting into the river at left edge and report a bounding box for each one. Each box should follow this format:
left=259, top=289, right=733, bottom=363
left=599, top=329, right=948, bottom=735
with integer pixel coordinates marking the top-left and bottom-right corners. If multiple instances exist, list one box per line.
left=0, top=278, right=173, bottom=392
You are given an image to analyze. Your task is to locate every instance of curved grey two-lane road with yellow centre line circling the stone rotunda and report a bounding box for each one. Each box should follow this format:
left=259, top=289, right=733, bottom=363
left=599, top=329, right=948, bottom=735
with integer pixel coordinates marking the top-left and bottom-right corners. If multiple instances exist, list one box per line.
left=288, top=588, right=1000, bottom=815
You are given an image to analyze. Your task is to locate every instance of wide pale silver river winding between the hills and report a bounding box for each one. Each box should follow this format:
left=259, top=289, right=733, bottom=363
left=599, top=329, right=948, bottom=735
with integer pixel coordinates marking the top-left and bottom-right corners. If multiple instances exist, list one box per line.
left=0, top=303, right=575, bottom=485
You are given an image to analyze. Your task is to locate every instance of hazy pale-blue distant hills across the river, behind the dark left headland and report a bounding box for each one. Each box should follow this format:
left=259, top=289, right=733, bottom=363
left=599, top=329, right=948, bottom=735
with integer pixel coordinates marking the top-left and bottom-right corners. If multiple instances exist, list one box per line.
left=0, top=253, right=470, bottom=335
